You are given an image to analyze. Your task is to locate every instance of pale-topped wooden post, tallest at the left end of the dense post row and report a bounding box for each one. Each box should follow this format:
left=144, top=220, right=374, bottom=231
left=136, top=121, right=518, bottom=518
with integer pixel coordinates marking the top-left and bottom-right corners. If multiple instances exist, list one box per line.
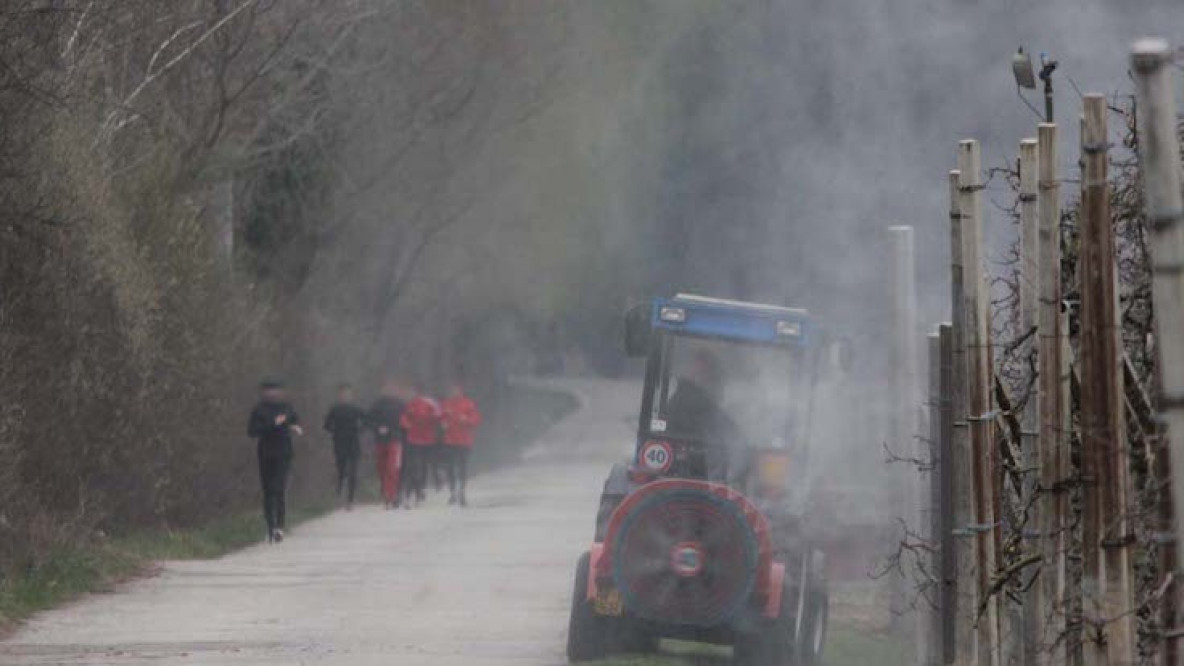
left=958, top=140, right=1000, bottom=666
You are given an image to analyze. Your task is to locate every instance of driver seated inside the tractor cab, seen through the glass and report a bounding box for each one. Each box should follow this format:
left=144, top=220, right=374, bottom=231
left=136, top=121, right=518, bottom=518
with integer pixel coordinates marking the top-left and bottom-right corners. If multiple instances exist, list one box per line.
left=665, top=348, right=746, bottom=482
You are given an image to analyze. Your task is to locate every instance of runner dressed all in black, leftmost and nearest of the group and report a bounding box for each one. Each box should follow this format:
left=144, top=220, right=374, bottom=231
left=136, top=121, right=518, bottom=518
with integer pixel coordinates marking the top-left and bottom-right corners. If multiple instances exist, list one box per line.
left=246, top=382, right=304, bottom=543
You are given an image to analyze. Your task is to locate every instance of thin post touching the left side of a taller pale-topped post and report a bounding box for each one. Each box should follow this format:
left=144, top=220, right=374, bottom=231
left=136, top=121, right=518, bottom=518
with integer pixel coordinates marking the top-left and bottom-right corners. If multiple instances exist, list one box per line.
left=950, top=171, right=978, bottom=666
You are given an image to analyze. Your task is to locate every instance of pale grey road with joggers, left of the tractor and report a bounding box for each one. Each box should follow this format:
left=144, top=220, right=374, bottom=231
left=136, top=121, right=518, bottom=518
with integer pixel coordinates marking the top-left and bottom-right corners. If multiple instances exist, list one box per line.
left=0, top=382, right=639, bottom=666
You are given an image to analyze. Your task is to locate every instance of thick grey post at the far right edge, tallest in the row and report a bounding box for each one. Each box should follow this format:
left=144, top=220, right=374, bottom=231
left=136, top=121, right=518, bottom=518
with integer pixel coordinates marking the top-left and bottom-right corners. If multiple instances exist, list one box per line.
left=1131, top=39, right=1184, bottom=665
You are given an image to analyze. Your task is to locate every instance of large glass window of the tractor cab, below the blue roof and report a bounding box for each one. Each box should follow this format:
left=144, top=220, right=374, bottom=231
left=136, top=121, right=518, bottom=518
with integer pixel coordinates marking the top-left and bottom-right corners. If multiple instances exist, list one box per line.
left=650, top=334, right=807, bottom=449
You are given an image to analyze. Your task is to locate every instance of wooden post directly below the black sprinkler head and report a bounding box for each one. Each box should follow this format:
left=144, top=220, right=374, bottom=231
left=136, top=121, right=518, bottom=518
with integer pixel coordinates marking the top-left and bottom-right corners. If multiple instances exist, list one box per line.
left=1036, top=123, right=1069, bottom=664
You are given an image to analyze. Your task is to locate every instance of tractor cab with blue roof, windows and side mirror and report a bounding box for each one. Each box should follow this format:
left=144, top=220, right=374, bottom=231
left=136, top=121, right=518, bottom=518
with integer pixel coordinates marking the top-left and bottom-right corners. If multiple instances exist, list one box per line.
left=625, top=294, right=824, bottom=490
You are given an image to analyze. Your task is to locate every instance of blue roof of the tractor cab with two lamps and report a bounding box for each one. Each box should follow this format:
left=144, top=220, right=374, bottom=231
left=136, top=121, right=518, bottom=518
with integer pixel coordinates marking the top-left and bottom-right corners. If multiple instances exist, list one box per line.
left=651, top=294, right=812, bottom=347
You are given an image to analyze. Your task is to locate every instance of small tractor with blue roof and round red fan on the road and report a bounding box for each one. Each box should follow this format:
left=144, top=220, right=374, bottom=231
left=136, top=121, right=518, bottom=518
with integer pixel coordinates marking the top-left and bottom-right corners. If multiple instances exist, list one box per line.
left=567, top=294, right=835, bottom=666
